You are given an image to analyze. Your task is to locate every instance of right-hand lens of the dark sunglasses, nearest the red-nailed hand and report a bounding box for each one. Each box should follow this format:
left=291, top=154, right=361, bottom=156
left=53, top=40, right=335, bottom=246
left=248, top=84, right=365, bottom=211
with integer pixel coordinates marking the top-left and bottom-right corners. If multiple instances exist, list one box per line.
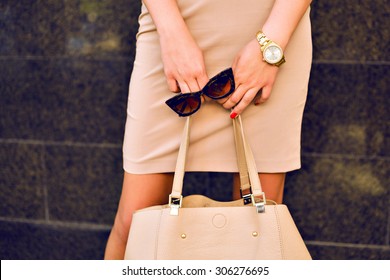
left=203, top=69, right=234, bottom=99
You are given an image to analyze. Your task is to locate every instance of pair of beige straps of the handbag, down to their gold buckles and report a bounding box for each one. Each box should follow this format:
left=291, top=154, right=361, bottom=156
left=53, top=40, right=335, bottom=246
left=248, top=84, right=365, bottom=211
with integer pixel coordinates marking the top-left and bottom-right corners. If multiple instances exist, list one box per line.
left=169, top=116, right=266, bottom=216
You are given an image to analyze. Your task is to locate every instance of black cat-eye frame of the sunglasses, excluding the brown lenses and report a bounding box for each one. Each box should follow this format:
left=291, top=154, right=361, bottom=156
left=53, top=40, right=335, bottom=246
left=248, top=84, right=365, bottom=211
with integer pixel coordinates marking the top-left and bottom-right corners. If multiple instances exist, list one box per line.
left=165, top=68, right=236, bottom=117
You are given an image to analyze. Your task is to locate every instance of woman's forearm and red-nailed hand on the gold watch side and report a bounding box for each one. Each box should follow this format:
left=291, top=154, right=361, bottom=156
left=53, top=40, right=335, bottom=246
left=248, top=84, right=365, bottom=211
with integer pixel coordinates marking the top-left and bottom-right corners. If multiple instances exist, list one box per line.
left=223, top=0, right=311, bottom=118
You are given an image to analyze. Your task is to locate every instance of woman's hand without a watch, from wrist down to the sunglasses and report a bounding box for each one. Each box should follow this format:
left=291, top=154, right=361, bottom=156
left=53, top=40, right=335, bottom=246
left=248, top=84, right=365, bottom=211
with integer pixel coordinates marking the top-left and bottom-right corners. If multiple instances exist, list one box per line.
left=160, top=30, right=209, bottom=93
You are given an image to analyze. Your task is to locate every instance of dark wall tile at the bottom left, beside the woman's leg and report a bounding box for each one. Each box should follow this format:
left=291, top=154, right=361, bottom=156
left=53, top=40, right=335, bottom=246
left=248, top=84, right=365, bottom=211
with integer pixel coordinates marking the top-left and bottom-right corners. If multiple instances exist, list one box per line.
left=0, top=222, right=109, bottom=260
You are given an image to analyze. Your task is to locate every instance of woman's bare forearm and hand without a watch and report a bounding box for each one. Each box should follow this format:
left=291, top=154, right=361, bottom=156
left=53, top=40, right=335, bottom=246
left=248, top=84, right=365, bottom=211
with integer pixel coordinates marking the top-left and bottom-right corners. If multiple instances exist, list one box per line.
left=143, top=0, right=209, bottom=93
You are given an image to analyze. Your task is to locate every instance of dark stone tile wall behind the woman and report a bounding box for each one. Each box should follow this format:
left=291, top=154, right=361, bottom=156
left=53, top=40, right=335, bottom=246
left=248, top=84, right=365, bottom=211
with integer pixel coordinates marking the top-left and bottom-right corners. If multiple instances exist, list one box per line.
left=0, top=0, right=390, bottom=259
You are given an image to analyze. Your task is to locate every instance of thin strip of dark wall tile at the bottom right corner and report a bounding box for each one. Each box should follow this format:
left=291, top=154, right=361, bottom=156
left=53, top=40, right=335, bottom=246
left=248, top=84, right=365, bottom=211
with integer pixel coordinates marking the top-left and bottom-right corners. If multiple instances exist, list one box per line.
left=307, top=245, right=390, bottom=260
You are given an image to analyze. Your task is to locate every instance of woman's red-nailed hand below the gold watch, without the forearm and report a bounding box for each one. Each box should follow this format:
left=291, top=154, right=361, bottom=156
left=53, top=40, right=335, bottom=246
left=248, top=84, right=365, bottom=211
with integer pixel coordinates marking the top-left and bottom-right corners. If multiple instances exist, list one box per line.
left=222, top=39, right=279, bottom=118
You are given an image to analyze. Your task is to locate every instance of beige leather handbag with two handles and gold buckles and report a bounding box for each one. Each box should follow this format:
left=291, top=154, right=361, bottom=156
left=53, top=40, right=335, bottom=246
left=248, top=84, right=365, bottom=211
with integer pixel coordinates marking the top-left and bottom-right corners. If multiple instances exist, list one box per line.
left=125, top=117, right=311, bottom=260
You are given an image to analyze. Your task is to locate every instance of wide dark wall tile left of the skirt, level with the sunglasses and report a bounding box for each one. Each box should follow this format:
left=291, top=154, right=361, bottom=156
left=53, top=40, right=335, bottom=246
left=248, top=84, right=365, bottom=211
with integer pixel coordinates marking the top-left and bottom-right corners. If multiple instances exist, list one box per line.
left=0, top=59, right=132, bottom=143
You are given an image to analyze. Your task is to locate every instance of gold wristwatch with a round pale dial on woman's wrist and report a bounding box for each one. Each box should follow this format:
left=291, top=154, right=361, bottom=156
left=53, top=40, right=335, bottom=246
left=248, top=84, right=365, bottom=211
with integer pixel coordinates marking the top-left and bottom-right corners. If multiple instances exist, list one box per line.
left=256, top=31, right=286, bottom=67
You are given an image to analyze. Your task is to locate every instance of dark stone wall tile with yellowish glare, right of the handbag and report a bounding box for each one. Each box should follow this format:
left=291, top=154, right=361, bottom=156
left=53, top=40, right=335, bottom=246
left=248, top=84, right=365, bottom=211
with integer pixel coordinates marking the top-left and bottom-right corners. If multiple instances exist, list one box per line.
left=285, top=156, right=390, bottom=245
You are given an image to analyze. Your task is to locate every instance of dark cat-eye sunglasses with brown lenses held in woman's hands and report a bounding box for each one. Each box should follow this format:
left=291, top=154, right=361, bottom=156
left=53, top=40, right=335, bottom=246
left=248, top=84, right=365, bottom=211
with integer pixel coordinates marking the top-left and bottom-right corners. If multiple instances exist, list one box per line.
left=165, top=68, right=235, bottom=117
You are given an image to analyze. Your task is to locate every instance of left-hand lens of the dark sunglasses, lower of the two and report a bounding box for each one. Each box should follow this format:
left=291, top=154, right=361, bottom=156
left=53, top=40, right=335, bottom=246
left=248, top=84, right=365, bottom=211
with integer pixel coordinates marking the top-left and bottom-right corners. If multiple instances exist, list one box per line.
left=165, top=94, right=201, bottom=117
